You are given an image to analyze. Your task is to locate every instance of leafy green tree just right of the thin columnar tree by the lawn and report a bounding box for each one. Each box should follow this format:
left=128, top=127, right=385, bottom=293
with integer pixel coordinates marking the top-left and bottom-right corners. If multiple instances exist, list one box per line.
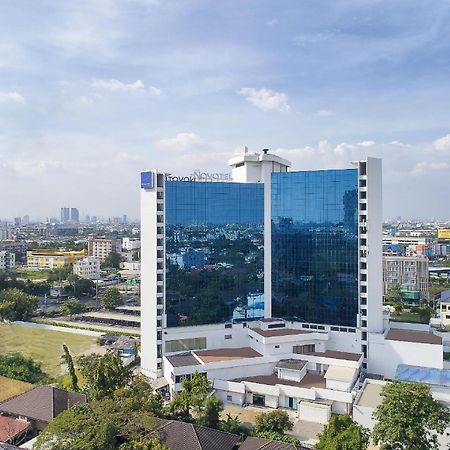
left=78, top=352, right=133, bottom=400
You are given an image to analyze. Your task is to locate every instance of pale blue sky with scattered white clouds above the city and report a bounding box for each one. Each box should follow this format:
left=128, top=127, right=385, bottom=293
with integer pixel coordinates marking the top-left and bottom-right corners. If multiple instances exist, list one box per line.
left=0, top=0, right=450, bottom=219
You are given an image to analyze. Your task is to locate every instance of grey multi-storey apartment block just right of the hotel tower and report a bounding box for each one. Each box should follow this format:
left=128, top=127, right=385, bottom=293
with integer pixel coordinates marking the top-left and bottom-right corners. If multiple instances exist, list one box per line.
left=383, top=254, right=429, bottom=303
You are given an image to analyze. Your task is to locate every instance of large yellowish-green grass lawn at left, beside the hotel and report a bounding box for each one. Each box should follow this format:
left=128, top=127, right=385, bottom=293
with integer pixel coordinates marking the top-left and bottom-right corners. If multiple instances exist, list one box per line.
left=0, top=324, right=100, bottom=378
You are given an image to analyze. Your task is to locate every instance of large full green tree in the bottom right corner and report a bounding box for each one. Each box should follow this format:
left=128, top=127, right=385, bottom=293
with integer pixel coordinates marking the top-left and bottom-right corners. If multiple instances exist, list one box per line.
left=372, top=381, right=450, bottom=450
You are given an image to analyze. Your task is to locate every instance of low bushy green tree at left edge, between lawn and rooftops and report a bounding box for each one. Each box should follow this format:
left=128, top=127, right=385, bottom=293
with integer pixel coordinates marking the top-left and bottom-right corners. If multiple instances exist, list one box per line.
left=0, top=353, right=50, bottom=384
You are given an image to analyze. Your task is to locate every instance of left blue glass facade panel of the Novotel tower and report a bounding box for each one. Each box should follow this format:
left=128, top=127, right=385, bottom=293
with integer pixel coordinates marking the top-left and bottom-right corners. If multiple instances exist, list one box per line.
left=165, top=181, right=264, bottom=327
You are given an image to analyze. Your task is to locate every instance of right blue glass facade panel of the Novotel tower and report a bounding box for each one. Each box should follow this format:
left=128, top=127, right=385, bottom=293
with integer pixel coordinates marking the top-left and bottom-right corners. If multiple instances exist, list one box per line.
left=271, top=169, right=358, bottom=326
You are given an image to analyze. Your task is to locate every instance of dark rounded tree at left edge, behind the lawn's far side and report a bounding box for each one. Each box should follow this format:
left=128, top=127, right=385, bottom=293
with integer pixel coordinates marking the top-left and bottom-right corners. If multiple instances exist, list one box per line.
left=0, top=288, right=38, bottom=321
